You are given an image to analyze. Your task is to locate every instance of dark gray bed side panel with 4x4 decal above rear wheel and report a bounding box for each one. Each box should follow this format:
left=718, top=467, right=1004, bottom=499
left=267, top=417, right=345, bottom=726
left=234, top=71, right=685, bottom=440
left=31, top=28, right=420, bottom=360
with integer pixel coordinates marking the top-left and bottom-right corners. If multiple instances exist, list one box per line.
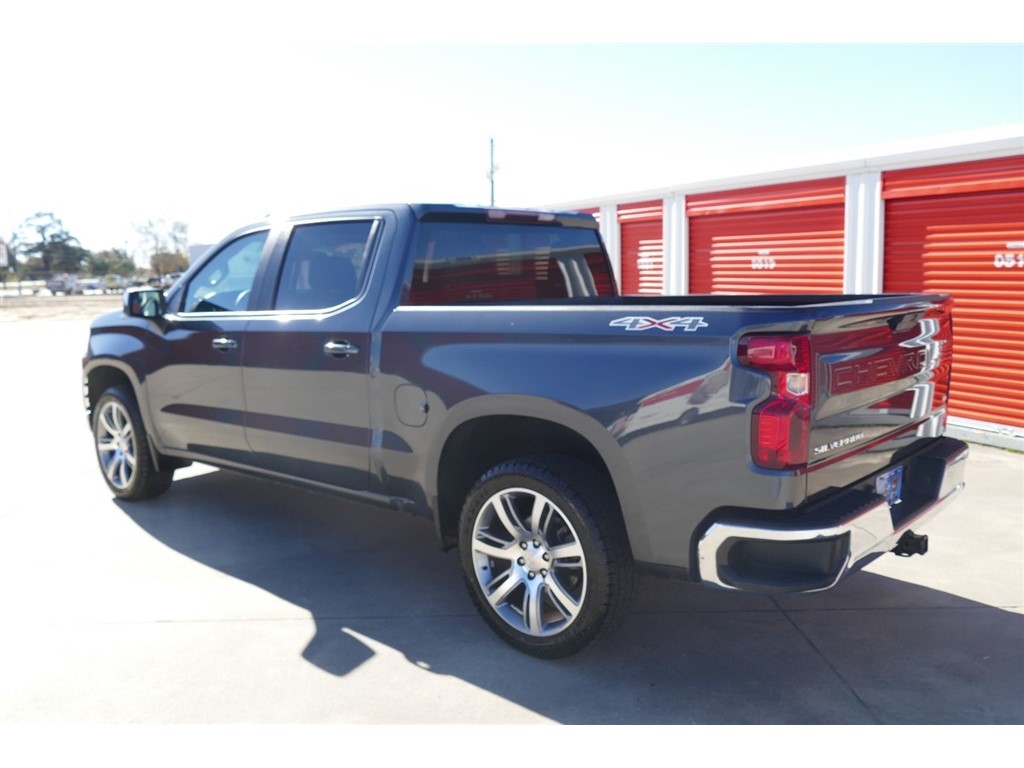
left=379, top=304, right=802, bottom=567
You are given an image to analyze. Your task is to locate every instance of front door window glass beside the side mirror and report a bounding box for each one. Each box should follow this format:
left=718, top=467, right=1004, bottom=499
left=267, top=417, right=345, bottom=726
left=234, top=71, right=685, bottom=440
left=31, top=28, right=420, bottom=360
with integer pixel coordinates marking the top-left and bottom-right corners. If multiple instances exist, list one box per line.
left=182, top=231, right=267, bottom=312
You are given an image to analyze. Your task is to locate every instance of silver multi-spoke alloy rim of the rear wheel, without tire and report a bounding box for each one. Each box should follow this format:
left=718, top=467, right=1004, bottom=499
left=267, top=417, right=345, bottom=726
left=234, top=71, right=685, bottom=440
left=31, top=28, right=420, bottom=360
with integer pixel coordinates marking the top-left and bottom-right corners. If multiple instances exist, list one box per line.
left=471, top=487, right=587, bottom=637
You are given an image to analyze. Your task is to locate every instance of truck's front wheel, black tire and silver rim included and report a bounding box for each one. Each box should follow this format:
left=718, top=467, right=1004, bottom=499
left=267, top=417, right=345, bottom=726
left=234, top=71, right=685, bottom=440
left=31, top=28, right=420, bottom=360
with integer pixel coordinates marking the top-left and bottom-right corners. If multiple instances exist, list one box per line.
left=92, top=386, right=174, bottom=501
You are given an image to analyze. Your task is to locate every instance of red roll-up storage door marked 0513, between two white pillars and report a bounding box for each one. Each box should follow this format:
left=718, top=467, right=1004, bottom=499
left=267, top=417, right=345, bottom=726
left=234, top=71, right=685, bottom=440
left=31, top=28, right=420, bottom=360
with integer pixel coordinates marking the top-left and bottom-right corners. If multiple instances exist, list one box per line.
left=686, top=177, right=846, bottom=294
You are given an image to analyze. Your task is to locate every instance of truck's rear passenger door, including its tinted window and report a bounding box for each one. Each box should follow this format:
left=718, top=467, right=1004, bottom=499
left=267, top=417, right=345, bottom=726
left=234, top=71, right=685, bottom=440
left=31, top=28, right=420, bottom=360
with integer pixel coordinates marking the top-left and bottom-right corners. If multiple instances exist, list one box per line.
left=243, top=216, right=382, bottom=490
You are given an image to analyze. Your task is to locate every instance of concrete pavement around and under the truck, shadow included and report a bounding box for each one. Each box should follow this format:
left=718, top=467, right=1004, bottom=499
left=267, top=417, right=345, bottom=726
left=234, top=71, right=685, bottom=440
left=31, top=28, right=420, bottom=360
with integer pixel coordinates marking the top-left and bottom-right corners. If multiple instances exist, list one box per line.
left=0, top=298, right=1024, bottom=729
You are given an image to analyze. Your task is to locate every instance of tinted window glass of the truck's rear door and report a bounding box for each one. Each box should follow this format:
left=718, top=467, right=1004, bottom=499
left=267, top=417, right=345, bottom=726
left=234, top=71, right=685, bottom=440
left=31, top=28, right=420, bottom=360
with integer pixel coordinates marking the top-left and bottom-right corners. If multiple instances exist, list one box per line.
left=273, top=221, right=374, bottom=309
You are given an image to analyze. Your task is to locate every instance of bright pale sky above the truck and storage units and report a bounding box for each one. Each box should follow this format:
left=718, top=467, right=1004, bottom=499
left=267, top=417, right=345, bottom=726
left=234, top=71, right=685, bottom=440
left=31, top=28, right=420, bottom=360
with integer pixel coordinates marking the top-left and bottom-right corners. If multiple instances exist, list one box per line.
left=0, top=0, right=1024, bottom=262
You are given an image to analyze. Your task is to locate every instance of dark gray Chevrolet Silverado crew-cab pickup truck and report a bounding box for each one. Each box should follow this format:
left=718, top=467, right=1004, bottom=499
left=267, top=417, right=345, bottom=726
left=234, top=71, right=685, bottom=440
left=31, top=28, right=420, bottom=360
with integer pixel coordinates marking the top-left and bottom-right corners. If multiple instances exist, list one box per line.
left=83, top=205, right=968, bottom=657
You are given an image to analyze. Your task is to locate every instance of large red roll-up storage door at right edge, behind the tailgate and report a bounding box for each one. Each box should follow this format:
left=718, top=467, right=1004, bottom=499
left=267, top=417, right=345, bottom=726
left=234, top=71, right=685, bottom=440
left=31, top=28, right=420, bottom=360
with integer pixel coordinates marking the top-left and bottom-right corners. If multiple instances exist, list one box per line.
left=882, top=156, right=1024, bottom=434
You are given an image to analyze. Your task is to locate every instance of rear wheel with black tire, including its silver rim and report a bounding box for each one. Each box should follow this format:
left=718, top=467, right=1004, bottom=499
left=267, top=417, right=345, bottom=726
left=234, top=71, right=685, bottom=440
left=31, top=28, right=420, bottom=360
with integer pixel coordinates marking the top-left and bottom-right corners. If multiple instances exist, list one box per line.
left=459, top=457, right=633, bottom=658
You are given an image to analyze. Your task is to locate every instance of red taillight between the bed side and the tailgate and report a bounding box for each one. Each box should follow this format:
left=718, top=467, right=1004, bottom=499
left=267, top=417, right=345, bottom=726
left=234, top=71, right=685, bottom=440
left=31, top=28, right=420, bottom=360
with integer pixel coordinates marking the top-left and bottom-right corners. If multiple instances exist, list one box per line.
left=739, top=336, right=814, bottom=470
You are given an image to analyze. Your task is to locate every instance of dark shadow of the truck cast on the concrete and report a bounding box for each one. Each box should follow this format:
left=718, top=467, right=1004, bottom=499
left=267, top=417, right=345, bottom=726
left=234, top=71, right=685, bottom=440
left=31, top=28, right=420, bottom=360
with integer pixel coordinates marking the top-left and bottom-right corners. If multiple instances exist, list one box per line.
left=119, top=471, right=1024, bottom=724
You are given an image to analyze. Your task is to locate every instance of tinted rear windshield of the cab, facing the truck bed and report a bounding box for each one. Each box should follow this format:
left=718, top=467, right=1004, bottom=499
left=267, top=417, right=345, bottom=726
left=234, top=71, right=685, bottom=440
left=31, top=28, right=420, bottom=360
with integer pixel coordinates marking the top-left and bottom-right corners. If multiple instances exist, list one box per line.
left=406, top=221, right=613, bottom=304
